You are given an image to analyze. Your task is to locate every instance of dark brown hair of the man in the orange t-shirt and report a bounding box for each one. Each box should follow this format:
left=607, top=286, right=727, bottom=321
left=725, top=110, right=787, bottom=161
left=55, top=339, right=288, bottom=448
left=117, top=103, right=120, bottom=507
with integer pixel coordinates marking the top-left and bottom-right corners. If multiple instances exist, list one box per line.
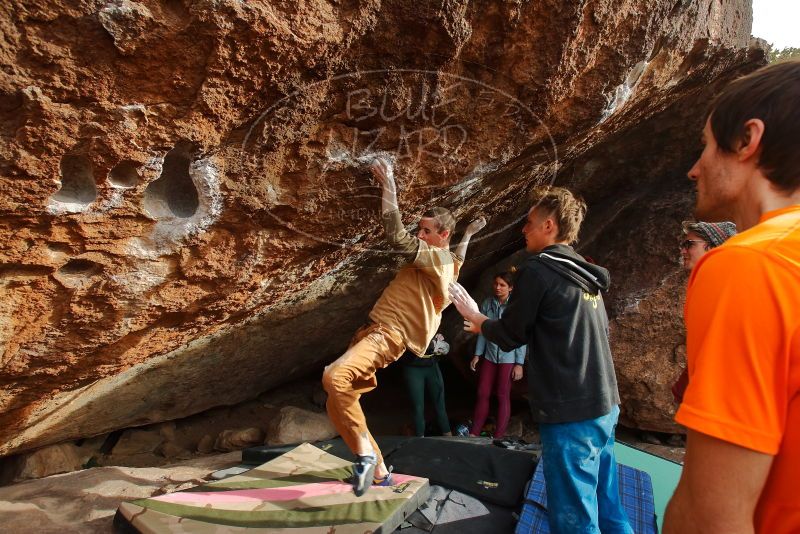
left=709, top=60, right=800, bottom=192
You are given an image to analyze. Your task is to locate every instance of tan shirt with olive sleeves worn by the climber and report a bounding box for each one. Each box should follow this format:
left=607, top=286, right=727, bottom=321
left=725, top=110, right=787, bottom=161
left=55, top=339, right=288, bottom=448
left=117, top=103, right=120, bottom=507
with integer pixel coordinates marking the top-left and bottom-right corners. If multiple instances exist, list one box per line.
left=369, top=210, right=464, bottom=356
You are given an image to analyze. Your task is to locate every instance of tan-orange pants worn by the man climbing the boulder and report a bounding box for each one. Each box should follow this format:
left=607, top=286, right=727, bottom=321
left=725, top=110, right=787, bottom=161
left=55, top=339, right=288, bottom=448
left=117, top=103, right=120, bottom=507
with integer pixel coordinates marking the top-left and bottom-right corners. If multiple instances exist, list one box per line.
left=322, top=323, right=406, bottom=464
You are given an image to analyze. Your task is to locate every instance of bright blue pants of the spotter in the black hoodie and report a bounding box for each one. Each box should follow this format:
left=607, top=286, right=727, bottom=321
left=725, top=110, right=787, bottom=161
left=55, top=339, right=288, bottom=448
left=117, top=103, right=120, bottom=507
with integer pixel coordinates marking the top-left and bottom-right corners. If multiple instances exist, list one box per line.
left=539, top=406, right=633, bottom=534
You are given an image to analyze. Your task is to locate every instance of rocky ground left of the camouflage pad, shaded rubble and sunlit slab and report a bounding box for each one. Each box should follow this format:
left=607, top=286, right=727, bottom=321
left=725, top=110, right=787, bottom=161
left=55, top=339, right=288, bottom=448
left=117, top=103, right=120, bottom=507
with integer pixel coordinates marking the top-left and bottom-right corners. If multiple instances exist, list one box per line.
left=0, top=380, right=335, bottom=534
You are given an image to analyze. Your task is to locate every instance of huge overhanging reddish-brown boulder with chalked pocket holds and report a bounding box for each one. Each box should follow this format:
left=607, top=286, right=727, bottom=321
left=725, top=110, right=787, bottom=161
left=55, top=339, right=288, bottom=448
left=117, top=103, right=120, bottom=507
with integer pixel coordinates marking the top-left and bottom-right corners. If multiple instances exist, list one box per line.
left=0, top=0, right=763, bottom=455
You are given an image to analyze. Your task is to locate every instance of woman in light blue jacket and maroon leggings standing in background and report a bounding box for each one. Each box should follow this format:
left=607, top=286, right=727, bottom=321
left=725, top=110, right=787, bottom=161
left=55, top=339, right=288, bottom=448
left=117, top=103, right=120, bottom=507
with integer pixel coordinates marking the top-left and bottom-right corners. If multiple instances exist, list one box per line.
left=469, top=272, right=526, bottom=439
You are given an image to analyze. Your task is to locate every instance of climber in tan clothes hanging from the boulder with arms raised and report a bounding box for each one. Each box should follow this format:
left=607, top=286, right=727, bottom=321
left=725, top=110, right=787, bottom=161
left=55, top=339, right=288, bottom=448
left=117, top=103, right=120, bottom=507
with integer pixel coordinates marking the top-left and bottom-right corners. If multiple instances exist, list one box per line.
left=322, top=157, right=486, bottom=496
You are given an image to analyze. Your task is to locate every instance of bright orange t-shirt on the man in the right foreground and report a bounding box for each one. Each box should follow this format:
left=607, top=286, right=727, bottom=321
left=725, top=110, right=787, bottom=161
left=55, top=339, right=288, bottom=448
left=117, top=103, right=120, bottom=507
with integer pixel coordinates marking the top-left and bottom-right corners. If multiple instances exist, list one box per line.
left=675, top=205, right=800, bottom=534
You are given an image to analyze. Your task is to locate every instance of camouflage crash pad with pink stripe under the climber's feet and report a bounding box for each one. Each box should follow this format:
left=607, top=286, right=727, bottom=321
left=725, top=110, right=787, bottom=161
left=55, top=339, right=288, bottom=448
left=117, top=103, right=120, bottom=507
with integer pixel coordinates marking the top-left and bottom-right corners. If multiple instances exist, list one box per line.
left=114, top=444, right=429, bottom=534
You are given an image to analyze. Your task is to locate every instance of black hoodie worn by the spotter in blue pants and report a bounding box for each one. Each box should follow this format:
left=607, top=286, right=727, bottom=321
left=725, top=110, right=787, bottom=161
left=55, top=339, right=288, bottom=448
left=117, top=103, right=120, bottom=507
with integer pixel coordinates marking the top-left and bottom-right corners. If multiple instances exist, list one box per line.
left=481, top=245, right=619, bottom=423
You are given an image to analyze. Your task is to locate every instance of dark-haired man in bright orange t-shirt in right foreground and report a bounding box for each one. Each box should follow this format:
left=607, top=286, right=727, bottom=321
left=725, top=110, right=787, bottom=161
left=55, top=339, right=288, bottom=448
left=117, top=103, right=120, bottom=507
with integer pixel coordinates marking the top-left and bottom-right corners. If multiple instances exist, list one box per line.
left=664, top=61, right=800, bottom=534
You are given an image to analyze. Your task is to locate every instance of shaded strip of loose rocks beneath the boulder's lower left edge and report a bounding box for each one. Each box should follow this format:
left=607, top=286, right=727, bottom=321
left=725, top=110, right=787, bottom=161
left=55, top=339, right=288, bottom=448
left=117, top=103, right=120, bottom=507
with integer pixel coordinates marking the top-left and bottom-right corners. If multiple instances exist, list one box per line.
left=0, top=380, right=335, bottom=483
